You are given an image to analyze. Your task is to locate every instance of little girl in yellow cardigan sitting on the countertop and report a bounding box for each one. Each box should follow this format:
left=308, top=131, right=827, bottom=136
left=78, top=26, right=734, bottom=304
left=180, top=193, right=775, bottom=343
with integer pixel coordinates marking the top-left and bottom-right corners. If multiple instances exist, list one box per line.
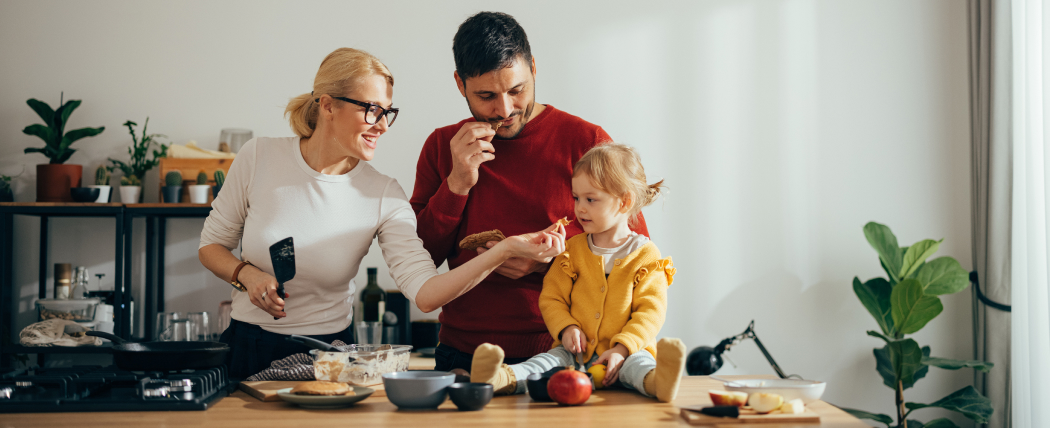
left=470, top=144, right=686, bottom=403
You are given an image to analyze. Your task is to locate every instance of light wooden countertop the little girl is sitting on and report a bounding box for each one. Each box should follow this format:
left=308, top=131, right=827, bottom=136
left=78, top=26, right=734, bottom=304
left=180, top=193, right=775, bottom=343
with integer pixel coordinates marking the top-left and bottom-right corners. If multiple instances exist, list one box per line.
left=0, top=377, right=869, bottom=428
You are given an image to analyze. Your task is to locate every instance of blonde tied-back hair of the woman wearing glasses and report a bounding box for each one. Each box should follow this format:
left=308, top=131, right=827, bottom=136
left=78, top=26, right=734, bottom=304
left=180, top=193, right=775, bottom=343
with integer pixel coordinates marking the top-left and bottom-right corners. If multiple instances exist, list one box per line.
left=285, top=47, right=394, bottom=138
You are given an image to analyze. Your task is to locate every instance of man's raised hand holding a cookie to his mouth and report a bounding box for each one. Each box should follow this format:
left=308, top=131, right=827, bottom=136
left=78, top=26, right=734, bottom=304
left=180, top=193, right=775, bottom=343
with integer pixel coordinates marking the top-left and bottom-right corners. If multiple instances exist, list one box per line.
left=448, top=122, right=496, bottom=195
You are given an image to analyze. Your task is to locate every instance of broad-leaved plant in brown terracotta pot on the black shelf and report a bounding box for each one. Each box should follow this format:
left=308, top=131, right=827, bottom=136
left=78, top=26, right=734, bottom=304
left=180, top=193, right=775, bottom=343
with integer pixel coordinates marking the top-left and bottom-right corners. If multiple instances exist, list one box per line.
left=22, top=93, right=106, bottom=202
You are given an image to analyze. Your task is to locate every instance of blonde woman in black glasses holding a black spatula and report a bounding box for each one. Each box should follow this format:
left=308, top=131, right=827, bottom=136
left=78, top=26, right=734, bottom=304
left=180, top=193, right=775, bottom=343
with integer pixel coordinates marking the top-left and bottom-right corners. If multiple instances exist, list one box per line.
left=198, top=48, right=565, bottom=379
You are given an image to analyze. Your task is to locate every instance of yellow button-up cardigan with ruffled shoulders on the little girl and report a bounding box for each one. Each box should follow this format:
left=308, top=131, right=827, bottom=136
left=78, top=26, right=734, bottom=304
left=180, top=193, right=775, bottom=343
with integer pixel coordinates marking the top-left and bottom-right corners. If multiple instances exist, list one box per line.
left=540, top=233, right=675, bottom=360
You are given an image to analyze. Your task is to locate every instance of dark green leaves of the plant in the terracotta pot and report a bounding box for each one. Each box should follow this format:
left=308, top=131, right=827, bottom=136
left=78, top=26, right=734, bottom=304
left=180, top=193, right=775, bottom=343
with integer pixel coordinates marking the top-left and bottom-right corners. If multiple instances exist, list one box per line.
left=22, top=97, right=106, bottom=164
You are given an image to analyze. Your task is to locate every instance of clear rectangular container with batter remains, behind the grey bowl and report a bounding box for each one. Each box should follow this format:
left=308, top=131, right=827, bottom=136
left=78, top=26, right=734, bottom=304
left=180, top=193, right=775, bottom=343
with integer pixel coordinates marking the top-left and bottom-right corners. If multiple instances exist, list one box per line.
left=310, top=345, right=412, bottom=386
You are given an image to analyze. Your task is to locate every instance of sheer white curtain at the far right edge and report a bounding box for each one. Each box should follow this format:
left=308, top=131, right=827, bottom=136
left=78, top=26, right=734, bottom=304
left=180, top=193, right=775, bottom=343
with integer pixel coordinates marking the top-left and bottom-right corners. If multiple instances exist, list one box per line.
left=1010, top=0, right=1050, bottom=428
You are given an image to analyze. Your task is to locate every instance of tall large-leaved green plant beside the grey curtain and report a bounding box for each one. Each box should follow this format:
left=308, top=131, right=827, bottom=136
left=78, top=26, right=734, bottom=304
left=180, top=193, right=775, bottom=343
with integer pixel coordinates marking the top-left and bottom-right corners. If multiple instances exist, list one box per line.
left=843, top=221, right=992, bottom=428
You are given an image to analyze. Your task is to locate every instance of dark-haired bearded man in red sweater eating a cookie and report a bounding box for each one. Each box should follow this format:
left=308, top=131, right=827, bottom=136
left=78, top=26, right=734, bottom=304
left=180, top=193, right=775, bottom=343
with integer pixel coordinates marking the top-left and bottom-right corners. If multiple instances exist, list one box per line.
left=411, top=12, right=649, bottom=370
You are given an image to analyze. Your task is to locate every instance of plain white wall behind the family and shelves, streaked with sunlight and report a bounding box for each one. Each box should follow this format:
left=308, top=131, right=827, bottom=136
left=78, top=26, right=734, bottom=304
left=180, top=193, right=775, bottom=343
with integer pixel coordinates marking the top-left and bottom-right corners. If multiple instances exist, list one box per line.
left=0, top=0, right=974, bottom=423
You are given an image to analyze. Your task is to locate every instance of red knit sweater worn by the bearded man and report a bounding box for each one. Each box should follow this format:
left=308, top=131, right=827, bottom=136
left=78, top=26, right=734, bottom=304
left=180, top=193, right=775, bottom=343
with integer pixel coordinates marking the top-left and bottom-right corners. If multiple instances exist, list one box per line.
left=411, top=106, right=649, bottom=358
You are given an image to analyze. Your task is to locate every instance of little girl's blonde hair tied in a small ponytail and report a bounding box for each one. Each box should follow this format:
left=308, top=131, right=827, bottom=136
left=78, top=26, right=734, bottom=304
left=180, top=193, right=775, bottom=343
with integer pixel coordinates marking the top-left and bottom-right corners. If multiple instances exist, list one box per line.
left=572, top=143, right=667, bottom=226
